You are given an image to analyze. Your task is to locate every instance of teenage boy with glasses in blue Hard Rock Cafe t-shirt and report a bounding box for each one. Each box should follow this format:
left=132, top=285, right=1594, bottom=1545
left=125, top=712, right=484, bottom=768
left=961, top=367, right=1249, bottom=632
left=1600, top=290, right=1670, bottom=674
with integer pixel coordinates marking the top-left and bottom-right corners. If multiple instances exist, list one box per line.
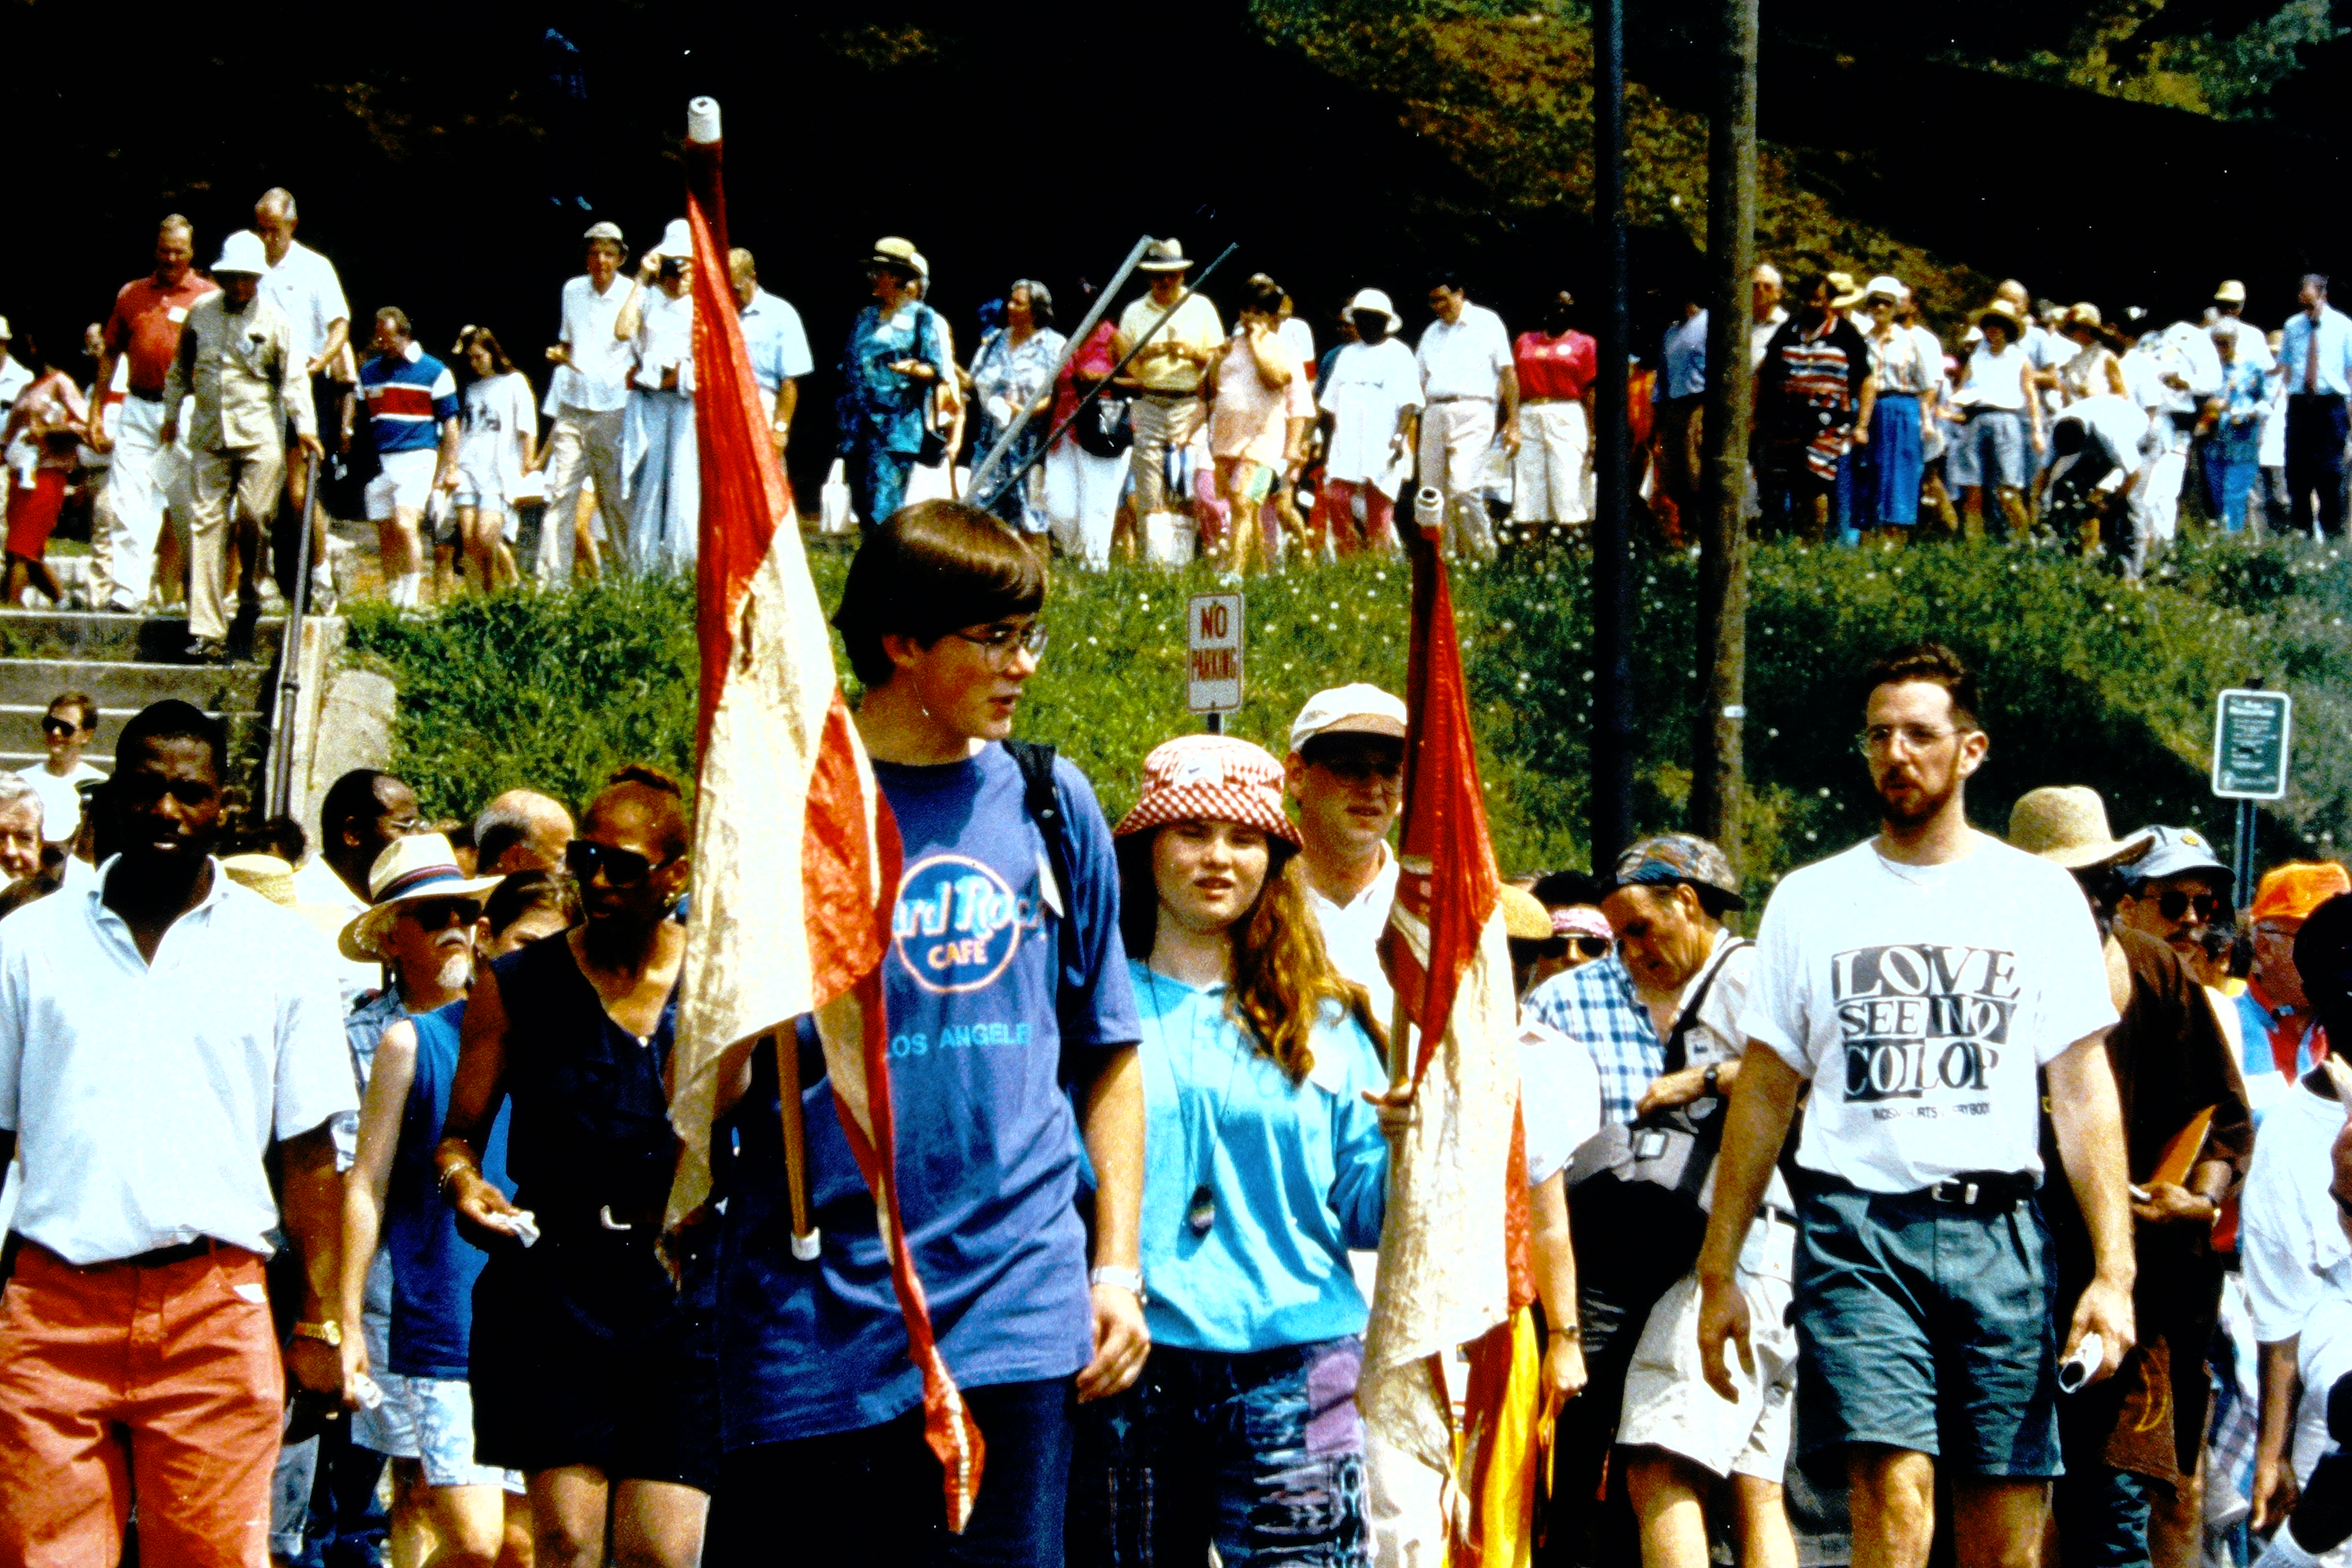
left=713, top=501, right=1150, bottom=1566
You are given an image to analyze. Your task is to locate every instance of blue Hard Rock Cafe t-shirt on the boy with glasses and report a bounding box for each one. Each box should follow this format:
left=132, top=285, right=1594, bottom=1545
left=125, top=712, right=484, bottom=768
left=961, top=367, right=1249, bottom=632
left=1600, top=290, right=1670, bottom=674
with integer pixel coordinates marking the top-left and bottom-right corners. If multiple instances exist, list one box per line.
left=720, top=745, right=1141, bottom=1450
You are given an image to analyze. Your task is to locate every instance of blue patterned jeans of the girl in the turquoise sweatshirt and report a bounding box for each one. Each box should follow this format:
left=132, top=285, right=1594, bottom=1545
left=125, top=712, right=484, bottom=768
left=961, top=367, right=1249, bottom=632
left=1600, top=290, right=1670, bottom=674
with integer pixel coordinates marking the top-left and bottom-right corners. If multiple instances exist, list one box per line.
left=1070, top=1338, right=1371, bottom=1568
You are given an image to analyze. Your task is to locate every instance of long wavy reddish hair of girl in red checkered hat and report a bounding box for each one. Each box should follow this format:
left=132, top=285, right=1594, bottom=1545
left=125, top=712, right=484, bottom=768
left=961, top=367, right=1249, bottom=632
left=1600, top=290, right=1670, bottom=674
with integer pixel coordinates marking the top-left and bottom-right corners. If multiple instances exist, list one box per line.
left=1117, top=828, right=1388, bottom=1084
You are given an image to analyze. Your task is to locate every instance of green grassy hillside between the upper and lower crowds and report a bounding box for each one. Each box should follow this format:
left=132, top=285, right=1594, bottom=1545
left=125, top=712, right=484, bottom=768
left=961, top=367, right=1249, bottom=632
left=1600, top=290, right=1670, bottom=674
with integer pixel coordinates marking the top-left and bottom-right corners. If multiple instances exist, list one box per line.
left=350, top=543, right=2352, bottom=907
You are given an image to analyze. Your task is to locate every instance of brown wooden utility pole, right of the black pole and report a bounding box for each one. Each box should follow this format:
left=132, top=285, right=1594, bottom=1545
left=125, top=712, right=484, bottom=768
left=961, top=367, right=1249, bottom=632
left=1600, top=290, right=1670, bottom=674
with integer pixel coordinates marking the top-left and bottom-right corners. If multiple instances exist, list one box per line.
left=1691, top=0, right=1757, bottom=863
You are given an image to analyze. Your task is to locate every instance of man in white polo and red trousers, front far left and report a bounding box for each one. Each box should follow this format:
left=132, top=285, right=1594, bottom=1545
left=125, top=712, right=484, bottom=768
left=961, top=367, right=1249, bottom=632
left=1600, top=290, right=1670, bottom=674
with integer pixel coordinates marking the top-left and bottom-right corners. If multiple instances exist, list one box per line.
left=0, top=701, right=358, bottom=1568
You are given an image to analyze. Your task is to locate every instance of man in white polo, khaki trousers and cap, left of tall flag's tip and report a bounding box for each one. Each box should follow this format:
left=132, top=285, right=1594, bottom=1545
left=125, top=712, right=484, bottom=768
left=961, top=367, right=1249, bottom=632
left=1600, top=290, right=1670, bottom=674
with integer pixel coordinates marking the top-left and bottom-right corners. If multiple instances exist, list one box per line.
left=534, top=223, right=633, bottom=588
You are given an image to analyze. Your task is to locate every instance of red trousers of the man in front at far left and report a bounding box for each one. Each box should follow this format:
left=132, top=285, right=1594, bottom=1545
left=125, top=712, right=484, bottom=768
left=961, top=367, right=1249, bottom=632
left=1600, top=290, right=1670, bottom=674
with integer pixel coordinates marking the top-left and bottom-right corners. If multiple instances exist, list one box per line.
left=0, top=1244, right=285, bottom=1568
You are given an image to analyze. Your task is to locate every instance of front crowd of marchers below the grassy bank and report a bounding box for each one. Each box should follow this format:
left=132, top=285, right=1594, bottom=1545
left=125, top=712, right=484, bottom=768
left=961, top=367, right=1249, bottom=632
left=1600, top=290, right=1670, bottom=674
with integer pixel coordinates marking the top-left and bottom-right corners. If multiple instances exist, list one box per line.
left=0, top=493, right=2352, bottom=1568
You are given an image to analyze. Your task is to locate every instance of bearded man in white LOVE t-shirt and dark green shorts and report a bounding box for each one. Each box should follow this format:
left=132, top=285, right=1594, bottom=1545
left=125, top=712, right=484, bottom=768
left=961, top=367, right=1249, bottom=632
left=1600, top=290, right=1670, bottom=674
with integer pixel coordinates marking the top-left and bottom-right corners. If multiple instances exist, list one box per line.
left=1698, top=644, right=2136, bottom=1568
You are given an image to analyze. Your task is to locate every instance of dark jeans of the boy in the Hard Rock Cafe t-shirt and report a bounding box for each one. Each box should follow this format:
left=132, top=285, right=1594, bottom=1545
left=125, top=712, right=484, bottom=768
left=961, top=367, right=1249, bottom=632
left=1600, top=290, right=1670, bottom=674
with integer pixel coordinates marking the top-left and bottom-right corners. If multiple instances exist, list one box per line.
left=703, top=1382, right=1077, bottom=1568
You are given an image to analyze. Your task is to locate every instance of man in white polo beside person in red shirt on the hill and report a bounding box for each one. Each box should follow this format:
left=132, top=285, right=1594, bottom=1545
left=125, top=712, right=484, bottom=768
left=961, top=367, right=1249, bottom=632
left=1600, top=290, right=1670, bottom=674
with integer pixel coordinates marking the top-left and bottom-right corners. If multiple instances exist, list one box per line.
left=1414, top=273, right=1519, bottom=562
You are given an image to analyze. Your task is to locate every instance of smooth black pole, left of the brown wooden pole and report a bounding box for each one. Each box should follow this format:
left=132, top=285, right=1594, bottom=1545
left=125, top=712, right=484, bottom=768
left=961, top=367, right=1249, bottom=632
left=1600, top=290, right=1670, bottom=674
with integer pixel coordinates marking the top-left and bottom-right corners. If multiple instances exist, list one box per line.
left=1592, top=0, right=1632, bottom=872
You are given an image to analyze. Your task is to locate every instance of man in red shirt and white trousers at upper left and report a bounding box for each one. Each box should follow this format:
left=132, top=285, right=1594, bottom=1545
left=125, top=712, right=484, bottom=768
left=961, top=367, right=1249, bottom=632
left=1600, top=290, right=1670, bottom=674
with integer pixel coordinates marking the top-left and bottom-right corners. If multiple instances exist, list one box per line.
left=87, top=212, right=216, bottom=614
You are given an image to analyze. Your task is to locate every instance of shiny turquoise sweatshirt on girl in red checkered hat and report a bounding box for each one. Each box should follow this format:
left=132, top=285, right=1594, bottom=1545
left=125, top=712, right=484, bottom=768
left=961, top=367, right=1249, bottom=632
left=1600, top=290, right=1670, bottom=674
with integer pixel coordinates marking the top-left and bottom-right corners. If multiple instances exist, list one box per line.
left=1129, top=962, right=1388, bottom=1354
